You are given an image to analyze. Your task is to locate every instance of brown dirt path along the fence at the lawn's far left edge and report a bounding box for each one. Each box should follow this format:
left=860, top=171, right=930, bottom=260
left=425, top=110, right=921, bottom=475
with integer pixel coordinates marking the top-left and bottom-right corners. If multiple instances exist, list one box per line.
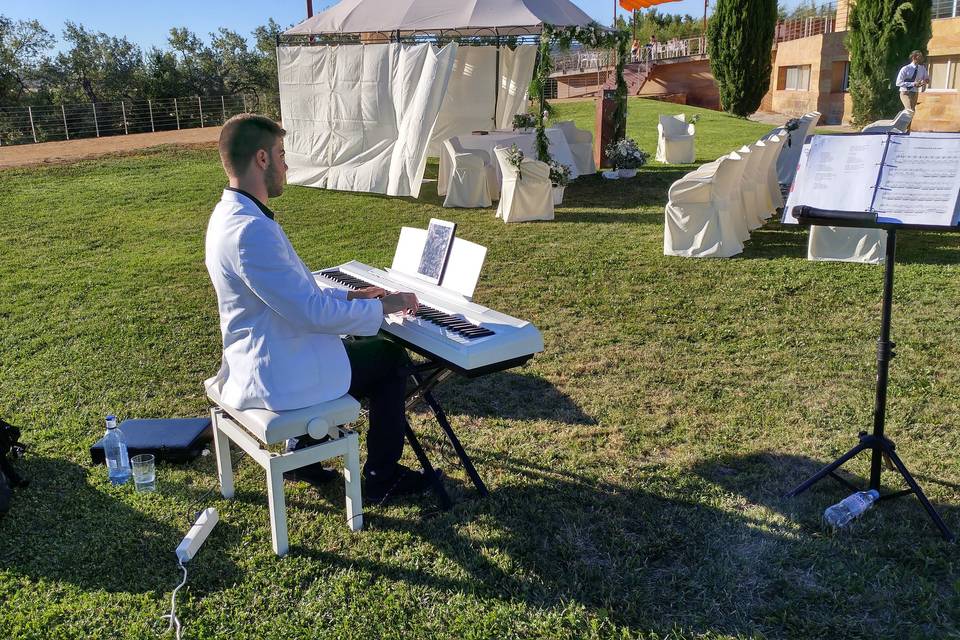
left=0, top=127, right=220, bottom=168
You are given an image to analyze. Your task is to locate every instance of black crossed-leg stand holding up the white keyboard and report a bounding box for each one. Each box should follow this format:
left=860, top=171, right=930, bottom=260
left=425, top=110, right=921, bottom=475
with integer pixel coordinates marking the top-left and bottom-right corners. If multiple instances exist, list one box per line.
left=406, top=360, right=489, bottom=511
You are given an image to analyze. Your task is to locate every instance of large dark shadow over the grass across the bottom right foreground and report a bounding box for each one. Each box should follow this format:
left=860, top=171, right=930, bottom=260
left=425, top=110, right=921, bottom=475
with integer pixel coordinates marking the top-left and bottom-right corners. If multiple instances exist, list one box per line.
left=293, top=454, right=958, bottom=637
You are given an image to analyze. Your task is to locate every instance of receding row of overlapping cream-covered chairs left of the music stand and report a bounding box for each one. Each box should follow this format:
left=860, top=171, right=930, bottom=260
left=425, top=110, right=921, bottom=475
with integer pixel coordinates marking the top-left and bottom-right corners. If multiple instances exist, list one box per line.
left=663, top=135, right=786, bottom=258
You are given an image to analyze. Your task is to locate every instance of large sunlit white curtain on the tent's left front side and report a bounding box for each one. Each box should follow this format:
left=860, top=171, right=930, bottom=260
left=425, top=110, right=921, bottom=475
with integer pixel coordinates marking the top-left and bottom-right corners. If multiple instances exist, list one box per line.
left=277, top=43, right=458, bottom=197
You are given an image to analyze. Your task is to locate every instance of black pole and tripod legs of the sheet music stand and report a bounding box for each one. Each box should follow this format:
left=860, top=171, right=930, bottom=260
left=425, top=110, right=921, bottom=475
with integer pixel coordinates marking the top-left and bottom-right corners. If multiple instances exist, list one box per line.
left=787, top=229, right=954, bottom=542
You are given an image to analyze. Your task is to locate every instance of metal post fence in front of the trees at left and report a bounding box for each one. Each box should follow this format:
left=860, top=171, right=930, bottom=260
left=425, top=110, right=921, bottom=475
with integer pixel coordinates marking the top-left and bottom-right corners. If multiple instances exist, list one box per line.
left=0, top=95, right=280, bottom=146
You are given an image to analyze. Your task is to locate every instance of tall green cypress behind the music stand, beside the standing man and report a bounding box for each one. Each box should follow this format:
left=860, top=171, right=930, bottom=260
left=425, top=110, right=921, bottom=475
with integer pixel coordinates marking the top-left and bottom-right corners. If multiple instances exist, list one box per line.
left=846, top=0, right=931, bottom=126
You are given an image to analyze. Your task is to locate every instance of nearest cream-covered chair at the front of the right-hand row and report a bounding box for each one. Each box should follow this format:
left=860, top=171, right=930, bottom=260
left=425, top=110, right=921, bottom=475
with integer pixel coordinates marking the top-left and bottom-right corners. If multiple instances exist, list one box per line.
left=663, top=153, right=745, bottom=258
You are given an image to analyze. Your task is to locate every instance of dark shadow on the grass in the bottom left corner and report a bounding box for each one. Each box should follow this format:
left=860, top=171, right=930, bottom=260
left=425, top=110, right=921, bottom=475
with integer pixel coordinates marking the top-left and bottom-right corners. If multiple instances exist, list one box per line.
left=0, top=455, right=240, bottom=593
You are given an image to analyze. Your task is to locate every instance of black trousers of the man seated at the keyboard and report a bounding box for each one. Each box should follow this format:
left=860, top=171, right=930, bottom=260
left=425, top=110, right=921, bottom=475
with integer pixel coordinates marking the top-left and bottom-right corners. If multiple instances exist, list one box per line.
left=343, top=336, right=410, bottom=476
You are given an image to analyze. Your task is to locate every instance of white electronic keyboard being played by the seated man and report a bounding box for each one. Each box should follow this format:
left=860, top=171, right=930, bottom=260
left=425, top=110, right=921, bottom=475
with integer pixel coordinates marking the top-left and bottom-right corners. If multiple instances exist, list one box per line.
left=313, top=261, right=543, bottom=375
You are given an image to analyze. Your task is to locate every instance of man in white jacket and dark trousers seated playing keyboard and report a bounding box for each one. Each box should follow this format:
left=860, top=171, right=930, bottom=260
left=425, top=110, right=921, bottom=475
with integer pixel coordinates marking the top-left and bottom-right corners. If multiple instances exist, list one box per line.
left=206, top=114, right=430, bottom=503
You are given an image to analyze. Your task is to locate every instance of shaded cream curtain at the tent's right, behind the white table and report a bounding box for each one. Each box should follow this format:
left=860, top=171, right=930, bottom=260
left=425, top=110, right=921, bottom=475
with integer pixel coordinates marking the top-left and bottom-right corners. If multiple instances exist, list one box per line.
left=429, top=44, right=537, bottom=156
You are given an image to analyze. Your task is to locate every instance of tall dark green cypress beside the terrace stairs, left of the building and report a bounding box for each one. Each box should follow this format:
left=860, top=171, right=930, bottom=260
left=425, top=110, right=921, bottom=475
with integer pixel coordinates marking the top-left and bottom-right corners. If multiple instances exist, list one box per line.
left=707, top=0, right=777, bottom=117
